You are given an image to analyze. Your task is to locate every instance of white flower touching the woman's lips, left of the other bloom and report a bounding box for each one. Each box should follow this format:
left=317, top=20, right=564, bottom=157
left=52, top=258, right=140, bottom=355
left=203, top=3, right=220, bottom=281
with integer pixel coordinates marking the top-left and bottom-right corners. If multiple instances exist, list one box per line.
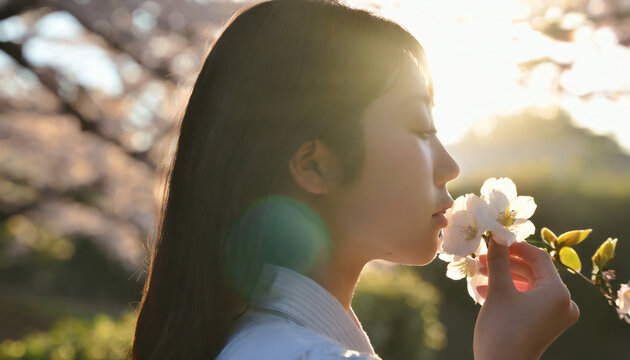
left=438, top=194, right=491, bottom=261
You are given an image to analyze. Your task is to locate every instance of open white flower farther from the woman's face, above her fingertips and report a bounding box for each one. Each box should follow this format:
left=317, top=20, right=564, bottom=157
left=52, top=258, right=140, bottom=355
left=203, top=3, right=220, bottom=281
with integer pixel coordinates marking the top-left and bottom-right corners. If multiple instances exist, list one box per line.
left=478, top=177, right=536, bottom=246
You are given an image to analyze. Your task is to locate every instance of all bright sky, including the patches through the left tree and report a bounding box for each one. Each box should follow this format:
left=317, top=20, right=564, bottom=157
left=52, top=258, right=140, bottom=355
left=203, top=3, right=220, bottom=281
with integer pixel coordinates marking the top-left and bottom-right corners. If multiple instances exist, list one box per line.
left=0, top=0, right=630, bottom=153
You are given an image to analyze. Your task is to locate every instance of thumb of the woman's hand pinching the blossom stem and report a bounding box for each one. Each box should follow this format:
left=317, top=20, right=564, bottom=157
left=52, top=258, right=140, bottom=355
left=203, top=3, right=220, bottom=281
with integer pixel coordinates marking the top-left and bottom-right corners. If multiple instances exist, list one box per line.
left=487, top=236, right=518, bottom=295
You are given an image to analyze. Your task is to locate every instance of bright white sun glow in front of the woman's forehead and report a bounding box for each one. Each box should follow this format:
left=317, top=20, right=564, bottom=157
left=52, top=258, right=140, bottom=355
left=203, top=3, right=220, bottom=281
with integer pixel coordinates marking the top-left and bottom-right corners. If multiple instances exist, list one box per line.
left=347, top=0, right=630, bottom=152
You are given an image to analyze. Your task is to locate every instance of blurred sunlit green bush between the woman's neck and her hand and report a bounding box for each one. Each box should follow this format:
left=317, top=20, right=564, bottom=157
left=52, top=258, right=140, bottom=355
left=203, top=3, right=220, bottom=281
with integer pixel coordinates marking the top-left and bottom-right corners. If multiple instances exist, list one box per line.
left=352, top=265, right=447, bottom=359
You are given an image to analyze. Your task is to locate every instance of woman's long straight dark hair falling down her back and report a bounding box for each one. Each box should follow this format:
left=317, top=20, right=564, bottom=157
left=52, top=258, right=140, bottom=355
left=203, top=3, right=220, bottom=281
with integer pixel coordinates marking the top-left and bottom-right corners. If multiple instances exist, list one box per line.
left=132, top=0, right=433, bottom=360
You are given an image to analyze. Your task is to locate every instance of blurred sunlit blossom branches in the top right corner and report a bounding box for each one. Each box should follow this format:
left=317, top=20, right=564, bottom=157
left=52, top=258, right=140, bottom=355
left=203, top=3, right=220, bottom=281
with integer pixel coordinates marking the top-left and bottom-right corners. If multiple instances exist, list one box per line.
left=515, top=0, right=630, bottom=101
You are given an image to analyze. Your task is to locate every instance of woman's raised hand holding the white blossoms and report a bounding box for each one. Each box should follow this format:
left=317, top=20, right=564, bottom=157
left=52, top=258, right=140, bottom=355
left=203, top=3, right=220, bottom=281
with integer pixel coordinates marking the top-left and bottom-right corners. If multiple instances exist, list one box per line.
left=473, top=240, right=580, bottom=360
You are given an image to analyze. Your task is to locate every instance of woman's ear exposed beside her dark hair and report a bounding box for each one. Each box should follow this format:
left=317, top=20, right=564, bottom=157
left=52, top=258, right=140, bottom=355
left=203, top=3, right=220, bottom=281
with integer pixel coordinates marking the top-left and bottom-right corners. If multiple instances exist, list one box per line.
left=289, top=139, right=341, bottom=194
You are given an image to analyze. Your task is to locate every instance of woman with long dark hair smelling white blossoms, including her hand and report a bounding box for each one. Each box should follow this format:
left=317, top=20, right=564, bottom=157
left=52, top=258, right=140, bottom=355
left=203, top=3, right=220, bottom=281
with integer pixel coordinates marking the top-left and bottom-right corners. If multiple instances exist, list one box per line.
left=132, top=0, right=579, bottom=360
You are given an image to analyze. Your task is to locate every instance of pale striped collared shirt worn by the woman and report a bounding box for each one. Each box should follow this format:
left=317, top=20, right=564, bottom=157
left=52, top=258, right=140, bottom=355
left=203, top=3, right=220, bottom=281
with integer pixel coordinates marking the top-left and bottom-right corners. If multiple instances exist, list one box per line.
left=217, top=264, right=381, bottom=360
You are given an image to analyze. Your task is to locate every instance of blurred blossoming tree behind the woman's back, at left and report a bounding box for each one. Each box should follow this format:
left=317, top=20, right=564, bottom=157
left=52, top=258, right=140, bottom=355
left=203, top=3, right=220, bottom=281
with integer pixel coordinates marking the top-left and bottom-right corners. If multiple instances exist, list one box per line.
left=0, top=0, right=240, bottom=344
